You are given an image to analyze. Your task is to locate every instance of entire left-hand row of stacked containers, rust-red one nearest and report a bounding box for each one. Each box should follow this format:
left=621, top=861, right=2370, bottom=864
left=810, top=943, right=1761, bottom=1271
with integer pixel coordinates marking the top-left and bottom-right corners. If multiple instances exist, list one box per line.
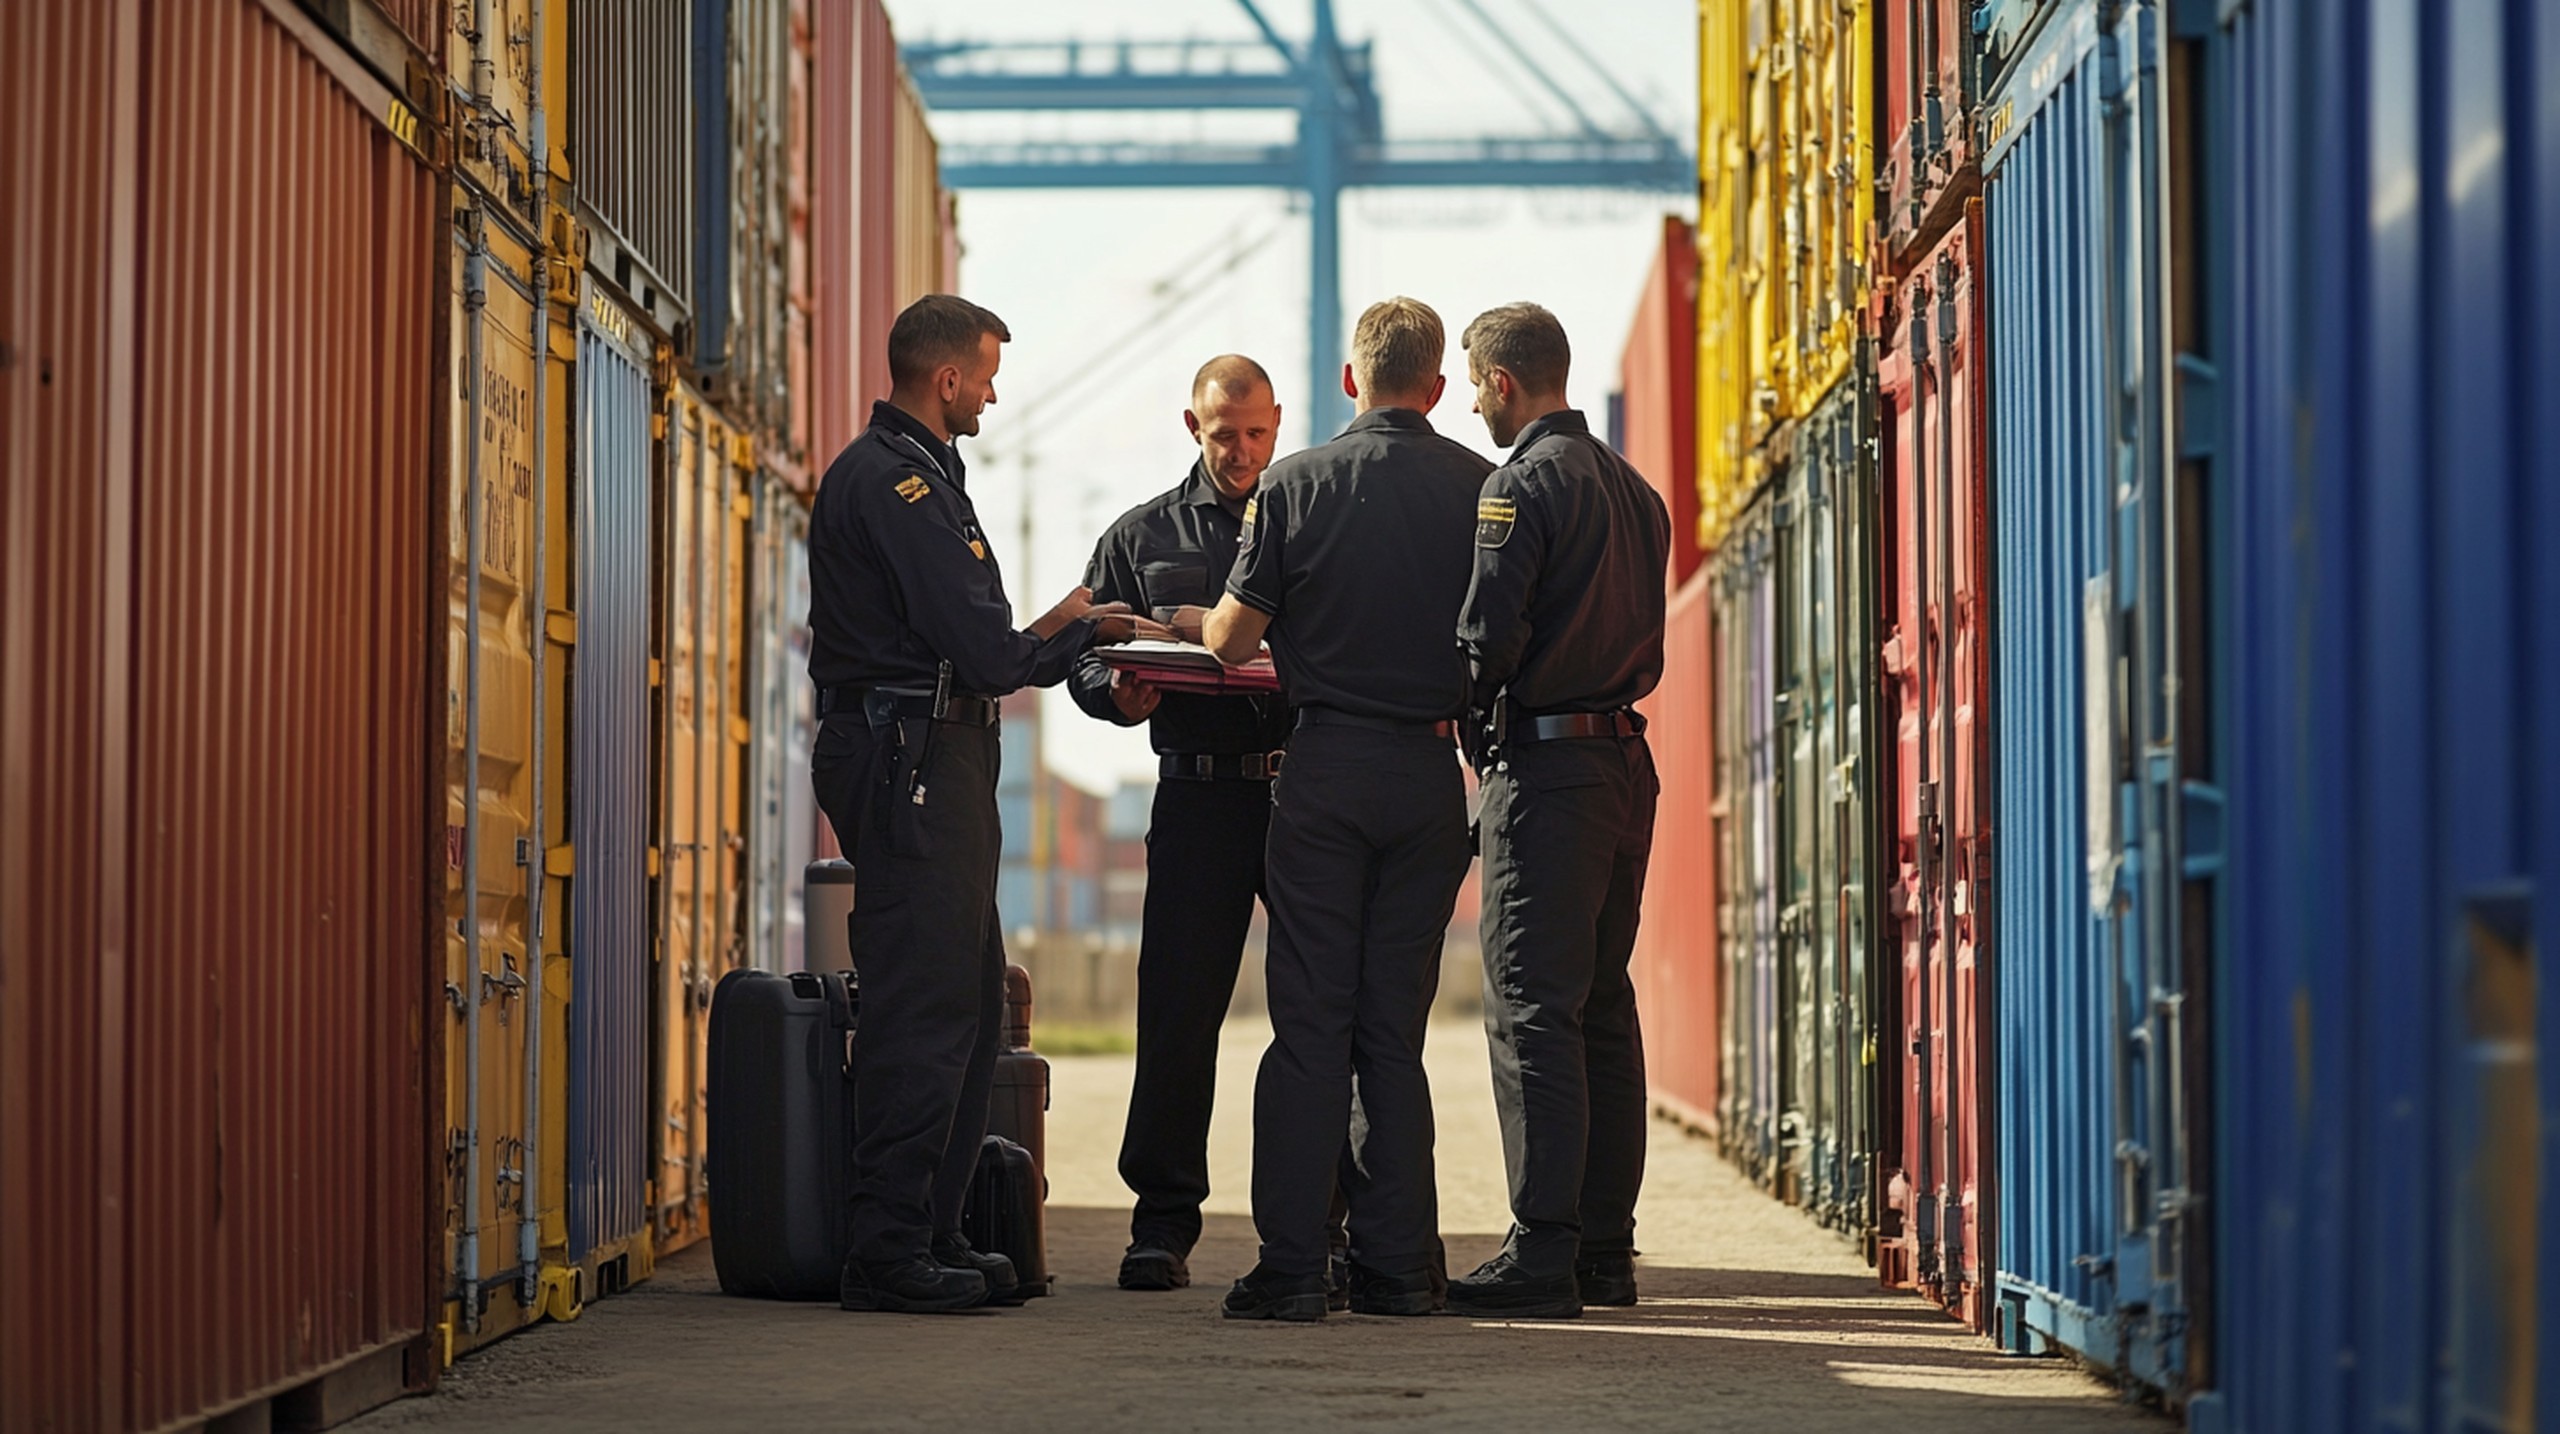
left=0, top=0, right=957, bottom=1429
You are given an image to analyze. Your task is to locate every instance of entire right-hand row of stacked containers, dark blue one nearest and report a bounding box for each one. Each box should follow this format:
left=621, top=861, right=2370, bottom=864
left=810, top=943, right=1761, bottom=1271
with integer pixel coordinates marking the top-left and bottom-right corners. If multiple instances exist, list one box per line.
left=1620, top=0, right=2560, bottom=1429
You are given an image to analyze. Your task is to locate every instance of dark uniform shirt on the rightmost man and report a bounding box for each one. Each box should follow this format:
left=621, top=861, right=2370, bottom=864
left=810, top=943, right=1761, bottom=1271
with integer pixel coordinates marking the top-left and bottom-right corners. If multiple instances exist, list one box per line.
left=1457, top=410, right=1672, bottom=712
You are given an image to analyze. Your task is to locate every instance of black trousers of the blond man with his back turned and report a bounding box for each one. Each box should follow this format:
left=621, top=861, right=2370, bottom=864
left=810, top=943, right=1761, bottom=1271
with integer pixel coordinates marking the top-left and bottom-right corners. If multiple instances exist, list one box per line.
left=1254, top=725, right=1469, bottom=1275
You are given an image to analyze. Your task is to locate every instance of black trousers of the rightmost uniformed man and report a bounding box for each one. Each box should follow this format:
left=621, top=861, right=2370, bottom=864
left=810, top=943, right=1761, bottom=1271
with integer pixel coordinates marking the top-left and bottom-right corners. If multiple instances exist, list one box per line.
left=1480, top=737, right=1661, bottom=1273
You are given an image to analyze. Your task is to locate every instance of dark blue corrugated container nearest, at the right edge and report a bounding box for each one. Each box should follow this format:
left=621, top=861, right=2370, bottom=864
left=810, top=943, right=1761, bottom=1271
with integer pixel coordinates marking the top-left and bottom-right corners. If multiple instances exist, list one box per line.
left=2184, top=0, right=2560, bottom=1431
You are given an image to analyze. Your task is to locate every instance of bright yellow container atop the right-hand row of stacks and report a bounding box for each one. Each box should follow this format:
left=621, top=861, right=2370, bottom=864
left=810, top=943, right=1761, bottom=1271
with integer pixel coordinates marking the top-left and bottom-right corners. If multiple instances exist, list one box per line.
left=1697, top=0, right=1874, bottom=545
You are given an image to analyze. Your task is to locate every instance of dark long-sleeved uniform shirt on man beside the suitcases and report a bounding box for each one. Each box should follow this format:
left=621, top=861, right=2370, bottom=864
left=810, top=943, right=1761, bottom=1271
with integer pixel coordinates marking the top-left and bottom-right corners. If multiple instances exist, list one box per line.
left=809, top=402, right=1093, bottom=697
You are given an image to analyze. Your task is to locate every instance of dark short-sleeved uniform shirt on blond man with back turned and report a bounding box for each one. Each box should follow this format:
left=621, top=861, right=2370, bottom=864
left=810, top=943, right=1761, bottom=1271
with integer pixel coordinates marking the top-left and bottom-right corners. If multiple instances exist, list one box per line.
left=1226, top=407, right=1492, bottom=722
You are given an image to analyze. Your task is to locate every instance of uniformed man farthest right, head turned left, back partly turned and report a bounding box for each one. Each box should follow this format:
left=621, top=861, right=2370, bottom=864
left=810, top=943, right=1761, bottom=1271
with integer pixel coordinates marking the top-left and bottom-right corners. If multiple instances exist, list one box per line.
left=1449, top=305, right=1672, bottom=1319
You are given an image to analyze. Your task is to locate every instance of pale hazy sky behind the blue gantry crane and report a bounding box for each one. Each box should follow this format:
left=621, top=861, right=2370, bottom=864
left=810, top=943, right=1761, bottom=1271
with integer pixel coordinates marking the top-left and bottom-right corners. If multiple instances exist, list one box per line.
left=888, top=0, right=1697, bottom=789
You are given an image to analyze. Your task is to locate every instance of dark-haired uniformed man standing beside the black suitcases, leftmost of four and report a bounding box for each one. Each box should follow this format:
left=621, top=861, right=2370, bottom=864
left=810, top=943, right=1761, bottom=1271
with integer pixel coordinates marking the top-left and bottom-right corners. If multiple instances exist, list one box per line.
left=809, top=294, right=1162, bottom=1314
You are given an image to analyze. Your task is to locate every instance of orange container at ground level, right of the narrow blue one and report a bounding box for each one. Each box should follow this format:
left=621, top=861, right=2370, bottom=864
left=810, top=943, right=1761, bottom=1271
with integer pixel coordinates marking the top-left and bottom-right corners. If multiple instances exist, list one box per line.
left=650, top=387, right=755, bottom=1255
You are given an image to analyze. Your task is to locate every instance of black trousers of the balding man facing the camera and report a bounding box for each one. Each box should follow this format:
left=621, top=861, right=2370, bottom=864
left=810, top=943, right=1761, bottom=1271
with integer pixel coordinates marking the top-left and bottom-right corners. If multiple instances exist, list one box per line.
left=1119, top=778, right=1272, bottom=1255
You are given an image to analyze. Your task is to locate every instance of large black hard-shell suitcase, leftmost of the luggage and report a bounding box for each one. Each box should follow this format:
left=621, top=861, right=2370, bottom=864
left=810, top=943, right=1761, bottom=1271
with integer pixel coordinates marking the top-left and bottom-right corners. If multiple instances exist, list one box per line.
left=709, top=971, right=858, bottom=1301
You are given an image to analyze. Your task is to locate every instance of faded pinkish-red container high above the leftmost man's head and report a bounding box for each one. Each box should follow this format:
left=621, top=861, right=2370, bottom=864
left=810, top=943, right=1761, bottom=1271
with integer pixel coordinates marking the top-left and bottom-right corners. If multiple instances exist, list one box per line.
left=809, top=0, right=957, bottom=458
